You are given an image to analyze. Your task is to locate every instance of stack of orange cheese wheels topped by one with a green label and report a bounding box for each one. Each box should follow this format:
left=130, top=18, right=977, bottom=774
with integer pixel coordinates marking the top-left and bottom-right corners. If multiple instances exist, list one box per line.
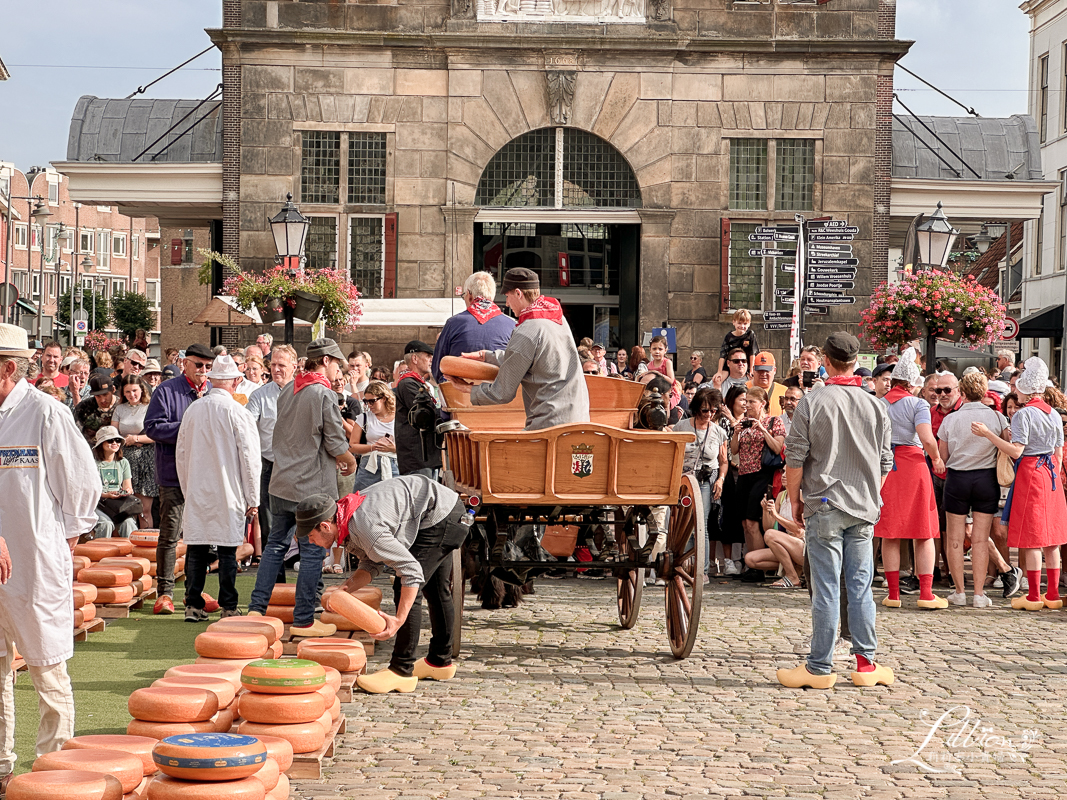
left=237, top=658, right=333, bottom=753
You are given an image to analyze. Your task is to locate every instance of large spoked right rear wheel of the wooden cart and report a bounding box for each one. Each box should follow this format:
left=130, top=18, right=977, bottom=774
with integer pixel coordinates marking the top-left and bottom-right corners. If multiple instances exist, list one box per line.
left=663, top=475, right=706, bottom=658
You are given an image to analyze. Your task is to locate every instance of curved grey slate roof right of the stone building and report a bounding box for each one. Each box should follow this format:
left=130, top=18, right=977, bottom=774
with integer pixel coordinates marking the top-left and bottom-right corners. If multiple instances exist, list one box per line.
left=893, top=114, right=1045, bottom=180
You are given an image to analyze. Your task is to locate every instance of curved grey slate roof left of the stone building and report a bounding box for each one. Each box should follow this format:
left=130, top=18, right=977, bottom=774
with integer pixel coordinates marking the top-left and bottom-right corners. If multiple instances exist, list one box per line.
left=67, top=95, right=222, bottom=164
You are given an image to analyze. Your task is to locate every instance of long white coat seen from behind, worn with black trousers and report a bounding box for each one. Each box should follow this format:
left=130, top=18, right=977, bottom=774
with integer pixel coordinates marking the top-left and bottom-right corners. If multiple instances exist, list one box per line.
left=174, top=389, right=262, bottom=547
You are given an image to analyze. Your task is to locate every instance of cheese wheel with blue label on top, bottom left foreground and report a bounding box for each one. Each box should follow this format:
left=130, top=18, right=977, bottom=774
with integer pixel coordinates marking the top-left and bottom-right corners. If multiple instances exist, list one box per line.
left=152, top=733, right=267, bottom=781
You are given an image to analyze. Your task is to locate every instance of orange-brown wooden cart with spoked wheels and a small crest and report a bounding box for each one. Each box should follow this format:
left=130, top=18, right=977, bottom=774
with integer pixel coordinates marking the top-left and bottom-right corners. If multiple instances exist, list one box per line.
left=442, top=377, right=706, bottom=658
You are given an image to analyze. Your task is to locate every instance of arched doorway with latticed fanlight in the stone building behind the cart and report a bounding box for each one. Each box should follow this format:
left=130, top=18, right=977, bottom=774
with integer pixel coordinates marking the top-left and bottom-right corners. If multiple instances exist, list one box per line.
left=474, top=127, right=641, bottom=348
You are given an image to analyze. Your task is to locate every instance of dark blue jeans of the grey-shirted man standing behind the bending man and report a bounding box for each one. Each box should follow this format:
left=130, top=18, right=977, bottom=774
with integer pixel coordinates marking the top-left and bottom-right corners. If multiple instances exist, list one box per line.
left=249, top=495, right=327, bottom=627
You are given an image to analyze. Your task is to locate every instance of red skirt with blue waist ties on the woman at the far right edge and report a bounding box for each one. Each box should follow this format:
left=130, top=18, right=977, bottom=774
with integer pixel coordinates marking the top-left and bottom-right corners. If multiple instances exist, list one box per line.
left=1007, top=455, right=1067, bottom=549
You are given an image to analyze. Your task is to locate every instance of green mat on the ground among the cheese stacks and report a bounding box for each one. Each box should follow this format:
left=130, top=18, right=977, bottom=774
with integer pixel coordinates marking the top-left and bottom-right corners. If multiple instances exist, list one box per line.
left=15, top=572, right=255, bottom=773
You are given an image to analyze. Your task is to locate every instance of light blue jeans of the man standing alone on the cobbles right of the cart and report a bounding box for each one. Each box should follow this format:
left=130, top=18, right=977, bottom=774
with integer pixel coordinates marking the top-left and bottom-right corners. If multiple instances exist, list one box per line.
left=805, top=498, right=878, bottom=675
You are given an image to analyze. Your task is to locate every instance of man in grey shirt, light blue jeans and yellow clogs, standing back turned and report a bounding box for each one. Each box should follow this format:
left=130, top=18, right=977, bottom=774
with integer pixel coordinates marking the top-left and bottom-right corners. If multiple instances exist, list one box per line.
left=778, top=333, right=893, bottom=689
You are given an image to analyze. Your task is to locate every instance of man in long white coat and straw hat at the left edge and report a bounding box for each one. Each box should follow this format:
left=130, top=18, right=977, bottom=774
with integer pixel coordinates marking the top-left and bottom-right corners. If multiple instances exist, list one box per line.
left=0, top=324, right=102, bottom=786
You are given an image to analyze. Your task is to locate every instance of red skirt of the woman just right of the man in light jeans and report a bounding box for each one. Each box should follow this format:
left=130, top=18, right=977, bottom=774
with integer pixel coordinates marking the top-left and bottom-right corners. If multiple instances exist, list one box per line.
left=874, top=445, right=941, bottom=539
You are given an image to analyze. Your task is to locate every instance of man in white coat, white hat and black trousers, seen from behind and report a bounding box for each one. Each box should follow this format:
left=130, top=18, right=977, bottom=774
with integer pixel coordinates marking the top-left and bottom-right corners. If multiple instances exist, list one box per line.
left=174, top=355, right=261, bottom=622
